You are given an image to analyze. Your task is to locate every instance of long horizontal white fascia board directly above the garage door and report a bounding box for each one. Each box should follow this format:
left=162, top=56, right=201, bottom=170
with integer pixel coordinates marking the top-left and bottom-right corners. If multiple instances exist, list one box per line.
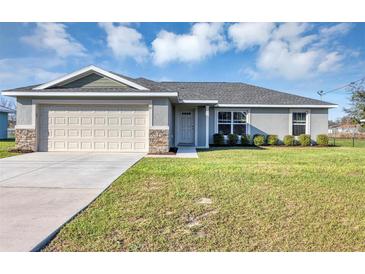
left=2, top=91, right=178, bottom=97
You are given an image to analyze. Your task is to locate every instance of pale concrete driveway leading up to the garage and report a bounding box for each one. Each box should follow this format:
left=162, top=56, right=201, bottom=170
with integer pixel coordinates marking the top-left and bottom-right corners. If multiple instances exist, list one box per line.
left=0, top=152, right=144, bottom=251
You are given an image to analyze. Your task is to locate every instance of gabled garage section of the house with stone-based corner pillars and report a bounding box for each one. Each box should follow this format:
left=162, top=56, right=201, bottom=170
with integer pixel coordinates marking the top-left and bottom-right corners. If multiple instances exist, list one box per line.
left=4, top=66, right=178, bottom=153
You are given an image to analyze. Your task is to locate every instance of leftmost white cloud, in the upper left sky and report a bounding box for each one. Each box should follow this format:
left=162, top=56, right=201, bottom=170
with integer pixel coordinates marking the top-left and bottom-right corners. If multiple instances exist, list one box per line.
left=21, top=23, right=86, bottom=57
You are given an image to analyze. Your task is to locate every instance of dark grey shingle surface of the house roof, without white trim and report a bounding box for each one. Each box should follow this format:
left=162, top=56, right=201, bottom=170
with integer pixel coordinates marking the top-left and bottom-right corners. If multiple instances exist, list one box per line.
left=4, top=70, right=334, bottom=105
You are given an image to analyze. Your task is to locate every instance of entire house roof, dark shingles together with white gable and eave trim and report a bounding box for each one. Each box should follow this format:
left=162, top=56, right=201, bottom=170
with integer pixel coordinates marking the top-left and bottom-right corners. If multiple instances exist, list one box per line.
left=3, top=66, right=337, bottom=108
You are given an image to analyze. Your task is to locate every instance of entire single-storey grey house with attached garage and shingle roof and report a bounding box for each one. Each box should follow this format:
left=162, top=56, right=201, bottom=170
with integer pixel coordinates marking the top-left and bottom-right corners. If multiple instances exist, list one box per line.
left=3, top=66, right=336, bottom=153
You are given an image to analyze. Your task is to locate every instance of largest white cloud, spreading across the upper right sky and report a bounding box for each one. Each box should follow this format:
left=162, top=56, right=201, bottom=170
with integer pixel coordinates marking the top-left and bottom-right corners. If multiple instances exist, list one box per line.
left=228, top=23, right=351, bottom=80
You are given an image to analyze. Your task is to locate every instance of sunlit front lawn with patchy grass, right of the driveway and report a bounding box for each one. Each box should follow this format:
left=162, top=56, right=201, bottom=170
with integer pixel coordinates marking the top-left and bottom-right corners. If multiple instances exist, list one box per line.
left=45, top=147, right=365, bottom=251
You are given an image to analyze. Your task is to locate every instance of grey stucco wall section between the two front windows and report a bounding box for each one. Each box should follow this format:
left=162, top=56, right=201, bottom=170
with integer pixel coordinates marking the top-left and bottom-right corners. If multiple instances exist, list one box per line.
left=250, top=108, right=289, bottom=140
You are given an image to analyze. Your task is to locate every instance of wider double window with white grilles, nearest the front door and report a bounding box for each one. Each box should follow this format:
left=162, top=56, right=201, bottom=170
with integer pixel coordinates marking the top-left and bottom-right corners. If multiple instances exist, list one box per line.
left=218, top=111, right=246, bottom=135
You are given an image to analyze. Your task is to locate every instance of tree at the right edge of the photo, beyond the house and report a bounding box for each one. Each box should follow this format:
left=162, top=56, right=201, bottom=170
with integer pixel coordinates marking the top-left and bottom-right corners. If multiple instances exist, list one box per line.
left=344, top=78, right=365, bottom=127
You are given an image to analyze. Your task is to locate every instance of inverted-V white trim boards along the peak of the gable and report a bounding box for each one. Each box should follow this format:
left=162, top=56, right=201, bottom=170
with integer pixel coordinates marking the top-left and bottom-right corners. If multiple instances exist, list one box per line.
left=33, top=66, right=149, bottom=90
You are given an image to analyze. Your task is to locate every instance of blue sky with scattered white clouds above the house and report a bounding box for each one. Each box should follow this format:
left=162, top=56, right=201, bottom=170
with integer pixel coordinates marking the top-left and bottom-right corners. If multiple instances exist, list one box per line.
left=0, top=23, right=365, bottom=119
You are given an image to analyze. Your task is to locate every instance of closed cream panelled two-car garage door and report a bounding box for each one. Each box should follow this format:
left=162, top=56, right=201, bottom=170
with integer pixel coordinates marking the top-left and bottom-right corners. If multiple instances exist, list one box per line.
left=39, top=105, right=148, bottom=152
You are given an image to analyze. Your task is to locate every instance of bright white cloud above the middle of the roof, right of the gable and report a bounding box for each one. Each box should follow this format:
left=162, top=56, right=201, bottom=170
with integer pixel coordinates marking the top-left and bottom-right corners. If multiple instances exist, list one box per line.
left=152, top=23, right=228, bottom=65
